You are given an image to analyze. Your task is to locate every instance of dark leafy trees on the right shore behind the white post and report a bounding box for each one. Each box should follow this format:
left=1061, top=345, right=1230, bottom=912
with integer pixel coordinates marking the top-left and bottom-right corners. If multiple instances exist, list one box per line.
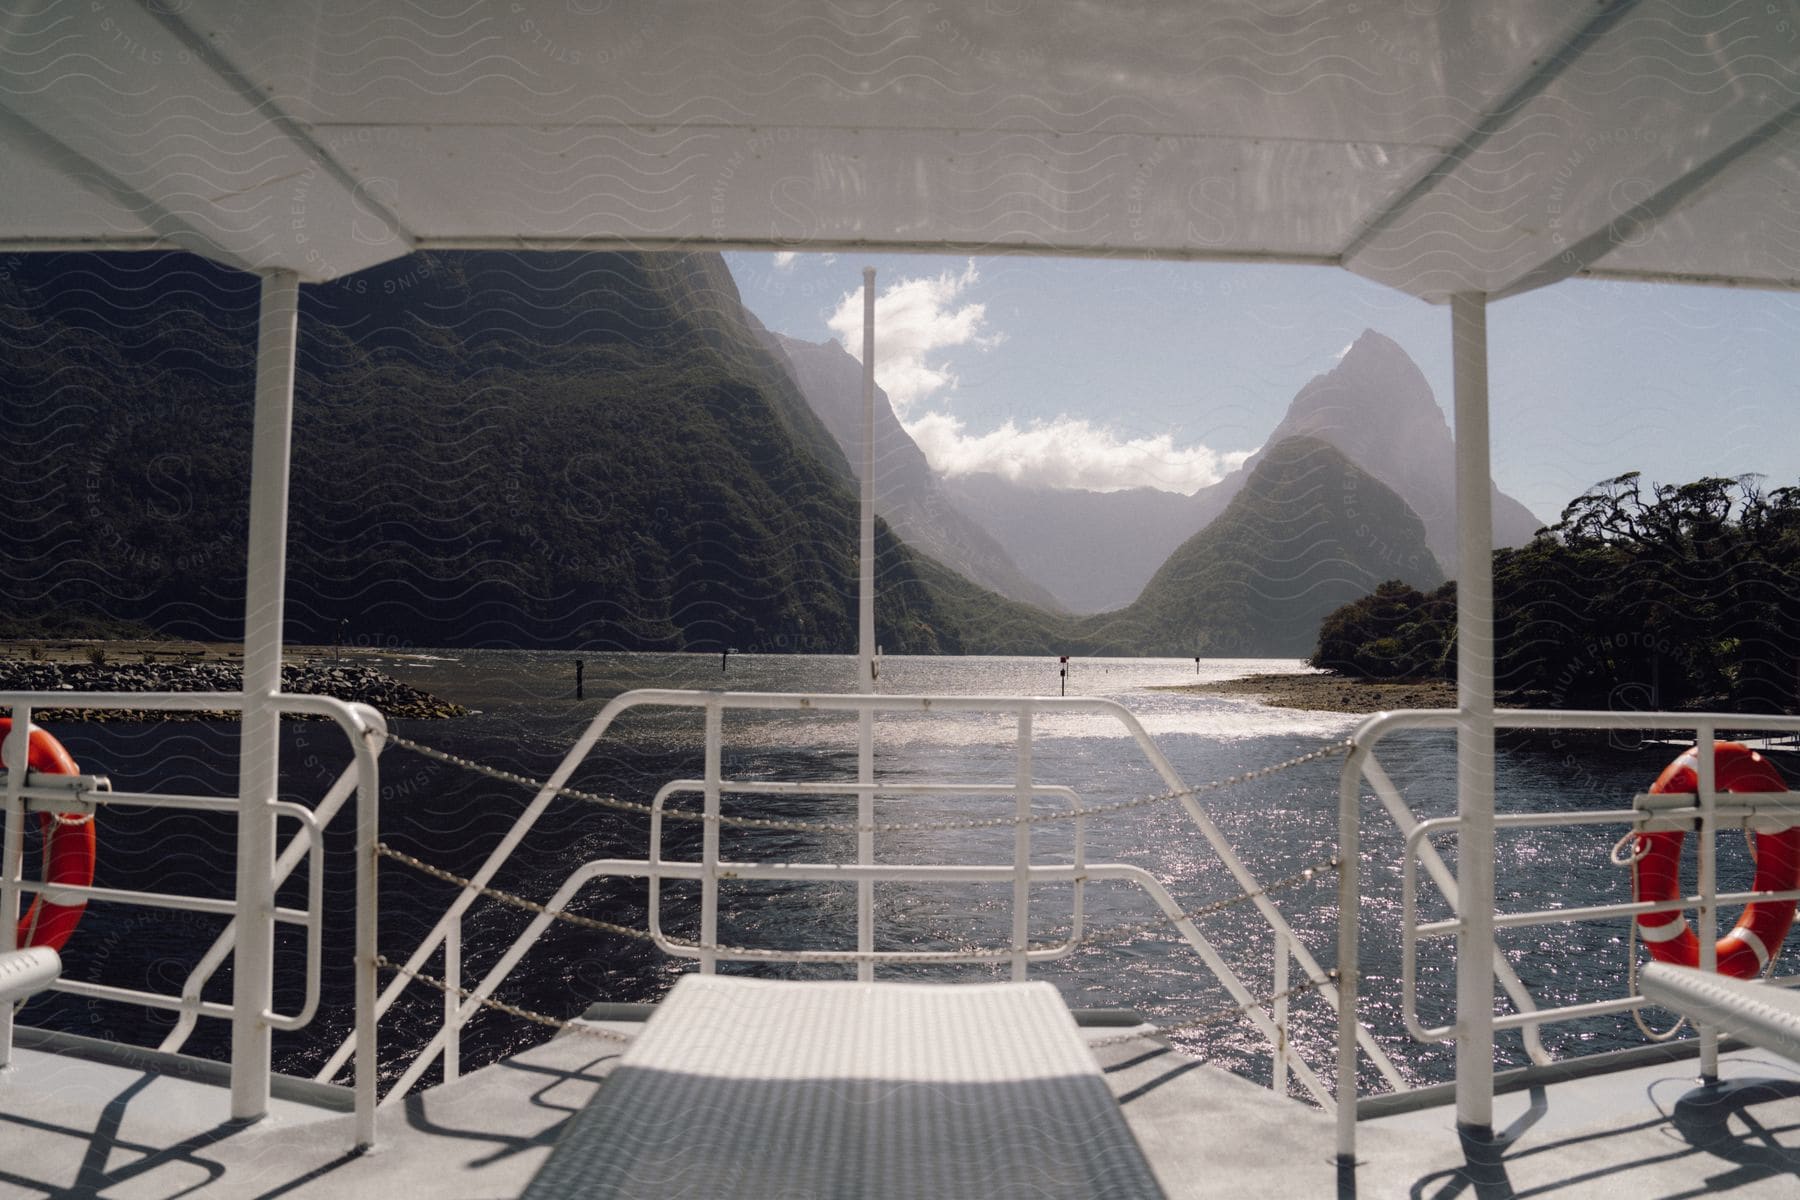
left=1312, top=471, right=1800, bottom=712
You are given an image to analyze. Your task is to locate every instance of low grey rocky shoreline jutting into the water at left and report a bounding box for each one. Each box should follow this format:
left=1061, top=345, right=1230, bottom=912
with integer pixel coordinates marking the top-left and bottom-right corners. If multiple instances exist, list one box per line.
left=0, top=658, right=468, bottom=721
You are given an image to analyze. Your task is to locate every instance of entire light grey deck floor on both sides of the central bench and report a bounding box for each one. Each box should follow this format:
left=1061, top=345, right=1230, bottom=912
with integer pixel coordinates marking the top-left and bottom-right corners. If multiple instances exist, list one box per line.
left=0, top=1022, right=1800, bottom=1200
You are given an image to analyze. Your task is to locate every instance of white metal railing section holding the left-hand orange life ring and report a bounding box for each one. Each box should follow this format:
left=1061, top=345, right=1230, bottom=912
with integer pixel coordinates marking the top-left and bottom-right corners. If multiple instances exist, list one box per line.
left=0, top=691, right=387, bottom=1146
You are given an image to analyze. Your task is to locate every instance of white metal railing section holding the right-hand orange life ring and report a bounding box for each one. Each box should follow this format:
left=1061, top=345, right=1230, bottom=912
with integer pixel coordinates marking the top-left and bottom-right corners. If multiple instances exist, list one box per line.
left=1337, top=709, right=1800, bottom=1159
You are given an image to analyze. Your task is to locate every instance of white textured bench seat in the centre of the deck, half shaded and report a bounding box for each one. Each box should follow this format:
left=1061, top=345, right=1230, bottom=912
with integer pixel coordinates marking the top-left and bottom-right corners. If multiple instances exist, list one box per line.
left=526, top=975, right=1163, bottom=1200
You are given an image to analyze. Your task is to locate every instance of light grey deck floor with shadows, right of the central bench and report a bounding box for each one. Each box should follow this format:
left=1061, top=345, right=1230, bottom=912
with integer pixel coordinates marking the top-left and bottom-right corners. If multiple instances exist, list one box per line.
left=1096, top=1042, right=1800, bottom=1200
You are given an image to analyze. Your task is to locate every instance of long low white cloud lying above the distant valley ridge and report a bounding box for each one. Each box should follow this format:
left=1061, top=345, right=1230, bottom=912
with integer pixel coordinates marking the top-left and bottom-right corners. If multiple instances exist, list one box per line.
left=905, top=412, right=1251, bottom=493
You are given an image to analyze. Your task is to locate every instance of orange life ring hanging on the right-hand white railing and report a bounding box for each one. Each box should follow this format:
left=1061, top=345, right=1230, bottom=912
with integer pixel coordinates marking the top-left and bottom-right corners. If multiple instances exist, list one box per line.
left=1631, top=741, right=1800, bottom=979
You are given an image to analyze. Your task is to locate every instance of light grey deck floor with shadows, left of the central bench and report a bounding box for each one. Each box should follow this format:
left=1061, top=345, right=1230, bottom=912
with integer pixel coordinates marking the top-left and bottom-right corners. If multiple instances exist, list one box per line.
left=0, top=1024, right=643, bottom=1200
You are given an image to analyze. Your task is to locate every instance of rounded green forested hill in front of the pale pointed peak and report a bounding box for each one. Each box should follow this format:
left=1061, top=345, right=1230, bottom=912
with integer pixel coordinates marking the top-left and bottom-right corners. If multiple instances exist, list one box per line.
left=1082, top=437, right=1444, bottom=657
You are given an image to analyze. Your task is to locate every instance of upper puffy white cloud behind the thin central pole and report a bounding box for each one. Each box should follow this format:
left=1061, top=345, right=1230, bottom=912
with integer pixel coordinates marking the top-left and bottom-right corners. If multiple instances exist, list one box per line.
left=826, top=261, right=1001, bottom=417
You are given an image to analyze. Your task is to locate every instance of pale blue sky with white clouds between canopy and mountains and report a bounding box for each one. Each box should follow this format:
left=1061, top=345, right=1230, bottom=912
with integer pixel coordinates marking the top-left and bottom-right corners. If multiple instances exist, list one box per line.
left=725, top=254, right=1800, bottom=520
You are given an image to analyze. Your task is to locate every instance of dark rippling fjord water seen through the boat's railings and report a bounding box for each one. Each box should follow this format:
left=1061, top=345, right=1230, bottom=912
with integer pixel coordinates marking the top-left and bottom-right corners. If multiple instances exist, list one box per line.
left=27, top=651, right=1748, bottom=1101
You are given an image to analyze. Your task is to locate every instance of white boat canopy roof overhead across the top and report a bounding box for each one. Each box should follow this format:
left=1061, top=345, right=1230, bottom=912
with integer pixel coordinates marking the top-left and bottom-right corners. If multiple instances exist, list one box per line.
left=0, top=0, right=1800, bottom=300
